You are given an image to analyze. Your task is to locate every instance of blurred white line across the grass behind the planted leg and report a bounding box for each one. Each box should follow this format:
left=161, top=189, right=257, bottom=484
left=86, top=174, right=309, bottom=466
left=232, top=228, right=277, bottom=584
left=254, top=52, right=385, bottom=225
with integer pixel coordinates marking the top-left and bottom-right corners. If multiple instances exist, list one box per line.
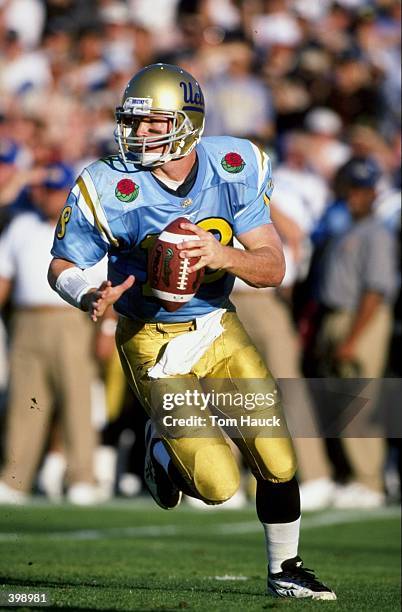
left=0, top=507, right=401, bottom=542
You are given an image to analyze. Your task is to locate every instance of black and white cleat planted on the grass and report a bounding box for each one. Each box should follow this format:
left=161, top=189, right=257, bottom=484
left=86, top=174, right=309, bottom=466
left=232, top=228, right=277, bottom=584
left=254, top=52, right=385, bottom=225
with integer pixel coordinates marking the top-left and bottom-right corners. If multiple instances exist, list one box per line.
left=268, top=557, right=336, bottom=601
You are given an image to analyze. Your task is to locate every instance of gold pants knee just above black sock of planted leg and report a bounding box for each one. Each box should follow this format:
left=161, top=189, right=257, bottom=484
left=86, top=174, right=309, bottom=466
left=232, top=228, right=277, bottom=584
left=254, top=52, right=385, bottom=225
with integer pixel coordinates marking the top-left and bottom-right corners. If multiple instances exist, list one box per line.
left=254, top=437, right=297, bottom=482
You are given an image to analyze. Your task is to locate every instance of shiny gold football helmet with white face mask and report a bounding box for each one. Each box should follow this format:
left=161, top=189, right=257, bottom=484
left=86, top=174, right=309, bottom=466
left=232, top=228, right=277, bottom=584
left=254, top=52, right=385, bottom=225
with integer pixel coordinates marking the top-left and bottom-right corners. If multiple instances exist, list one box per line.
left=116, top=64, right=205, bottom=166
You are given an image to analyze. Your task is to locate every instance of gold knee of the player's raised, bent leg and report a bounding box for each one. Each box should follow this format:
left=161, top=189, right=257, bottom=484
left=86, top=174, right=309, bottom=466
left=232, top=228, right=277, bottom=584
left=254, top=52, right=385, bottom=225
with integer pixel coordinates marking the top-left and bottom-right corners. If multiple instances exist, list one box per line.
left=193, top=444, right=240, bottom=504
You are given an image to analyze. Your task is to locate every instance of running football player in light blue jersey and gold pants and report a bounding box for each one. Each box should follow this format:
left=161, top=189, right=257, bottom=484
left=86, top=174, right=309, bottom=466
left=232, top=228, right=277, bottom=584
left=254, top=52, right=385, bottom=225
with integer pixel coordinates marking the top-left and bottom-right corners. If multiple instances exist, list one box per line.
left=49, top=64, right=336, bottom=600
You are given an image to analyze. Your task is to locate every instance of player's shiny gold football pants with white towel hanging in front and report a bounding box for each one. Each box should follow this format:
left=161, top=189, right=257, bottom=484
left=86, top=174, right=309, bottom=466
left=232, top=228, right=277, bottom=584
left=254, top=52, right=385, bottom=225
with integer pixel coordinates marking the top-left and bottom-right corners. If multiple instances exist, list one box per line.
left=116, top=312, right=296, bottom=504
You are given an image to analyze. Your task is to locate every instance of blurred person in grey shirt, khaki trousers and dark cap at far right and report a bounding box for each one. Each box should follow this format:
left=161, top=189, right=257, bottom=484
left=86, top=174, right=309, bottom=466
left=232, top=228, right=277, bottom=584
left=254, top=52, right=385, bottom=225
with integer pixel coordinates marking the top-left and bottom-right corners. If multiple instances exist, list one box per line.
left=318, top=158, right=398, bottom=508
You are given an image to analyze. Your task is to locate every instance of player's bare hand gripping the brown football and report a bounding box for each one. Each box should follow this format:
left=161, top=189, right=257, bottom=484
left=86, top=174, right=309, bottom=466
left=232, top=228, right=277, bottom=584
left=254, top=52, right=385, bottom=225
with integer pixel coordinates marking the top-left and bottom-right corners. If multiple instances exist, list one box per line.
left=177, top=223, right=228, bottom=272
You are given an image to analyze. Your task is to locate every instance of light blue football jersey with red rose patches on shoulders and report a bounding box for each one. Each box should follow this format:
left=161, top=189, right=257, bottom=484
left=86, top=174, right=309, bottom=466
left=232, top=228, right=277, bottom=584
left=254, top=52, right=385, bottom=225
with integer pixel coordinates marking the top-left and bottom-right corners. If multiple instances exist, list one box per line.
left=52, top=137, right=272, bottom=322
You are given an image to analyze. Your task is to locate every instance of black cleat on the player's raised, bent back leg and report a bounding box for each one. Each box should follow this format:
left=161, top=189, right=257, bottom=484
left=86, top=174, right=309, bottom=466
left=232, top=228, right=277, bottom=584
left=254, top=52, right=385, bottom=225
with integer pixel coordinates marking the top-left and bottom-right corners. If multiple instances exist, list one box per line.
left=144, top=421, right=182, bottom=510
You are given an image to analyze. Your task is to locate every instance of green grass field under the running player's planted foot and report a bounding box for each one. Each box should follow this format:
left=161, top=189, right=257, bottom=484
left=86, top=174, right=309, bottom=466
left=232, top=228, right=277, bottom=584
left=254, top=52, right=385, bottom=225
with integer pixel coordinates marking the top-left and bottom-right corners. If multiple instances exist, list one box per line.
left=0, top=500, right=400, bottom=612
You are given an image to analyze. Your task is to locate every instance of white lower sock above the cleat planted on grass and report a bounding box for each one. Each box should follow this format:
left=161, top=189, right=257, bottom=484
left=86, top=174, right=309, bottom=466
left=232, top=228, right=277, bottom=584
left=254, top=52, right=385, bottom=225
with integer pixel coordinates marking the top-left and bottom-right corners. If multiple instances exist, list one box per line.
left=262, top=517, right=300, bottom=574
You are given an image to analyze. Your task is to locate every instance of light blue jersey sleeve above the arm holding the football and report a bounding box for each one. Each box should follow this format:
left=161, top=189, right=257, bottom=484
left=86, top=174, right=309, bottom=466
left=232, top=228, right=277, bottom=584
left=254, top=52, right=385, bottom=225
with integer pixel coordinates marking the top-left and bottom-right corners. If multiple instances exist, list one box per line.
left=234, top=143, right=273, bottom=236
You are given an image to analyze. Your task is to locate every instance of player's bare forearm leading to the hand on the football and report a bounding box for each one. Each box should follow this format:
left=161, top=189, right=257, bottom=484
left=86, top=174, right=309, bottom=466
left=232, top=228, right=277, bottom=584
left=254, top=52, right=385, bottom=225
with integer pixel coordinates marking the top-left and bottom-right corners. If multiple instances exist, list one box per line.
left=223, top=246, right=286, bottom=288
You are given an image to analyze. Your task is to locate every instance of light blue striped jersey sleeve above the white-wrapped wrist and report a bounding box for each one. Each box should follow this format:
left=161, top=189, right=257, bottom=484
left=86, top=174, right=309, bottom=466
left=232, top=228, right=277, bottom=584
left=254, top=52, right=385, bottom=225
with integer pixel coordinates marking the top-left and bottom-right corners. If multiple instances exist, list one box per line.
left=51, top=177, right=109, bottom=269
